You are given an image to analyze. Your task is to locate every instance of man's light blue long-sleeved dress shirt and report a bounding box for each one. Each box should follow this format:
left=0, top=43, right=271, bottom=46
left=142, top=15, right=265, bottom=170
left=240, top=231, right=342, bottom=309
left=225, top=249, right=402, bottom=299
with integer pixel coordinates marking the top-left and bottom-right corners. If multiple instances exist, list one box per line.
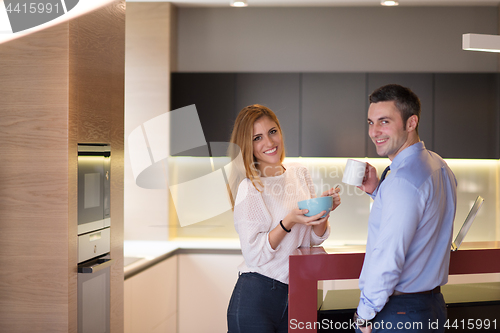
left=357, top=141, right=457, bottom=319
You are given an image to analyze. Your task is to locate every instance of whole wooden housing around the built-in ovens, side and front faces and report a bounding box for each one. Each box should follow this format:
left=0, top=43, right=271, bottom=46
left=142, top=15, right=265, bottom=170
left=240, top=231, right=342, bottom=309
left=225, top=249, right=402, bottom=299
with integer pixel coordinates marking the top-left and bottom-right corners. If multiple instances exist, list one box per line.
left=0, top=1, right=125, bottom=333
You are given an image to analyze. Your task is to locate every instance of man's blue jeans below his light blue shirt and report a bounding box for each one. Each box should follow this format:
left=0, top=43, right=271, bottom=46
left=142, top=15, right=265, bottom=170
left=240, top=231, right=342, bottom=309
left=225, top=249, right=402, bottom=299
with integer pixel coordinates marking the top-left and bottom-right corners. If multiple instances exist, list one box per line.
left=356, top=293, right=446, bottom=333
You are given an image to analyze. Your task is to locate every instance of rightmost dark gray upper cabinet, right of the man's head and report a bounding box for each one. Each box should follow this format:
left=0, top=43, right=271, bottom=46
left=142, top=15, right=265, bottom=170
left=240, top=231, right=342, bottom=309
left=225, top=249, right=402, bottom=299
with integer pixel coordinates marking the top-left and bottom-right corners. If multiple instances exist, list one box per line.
left=434, top=73, right=499, bottom=158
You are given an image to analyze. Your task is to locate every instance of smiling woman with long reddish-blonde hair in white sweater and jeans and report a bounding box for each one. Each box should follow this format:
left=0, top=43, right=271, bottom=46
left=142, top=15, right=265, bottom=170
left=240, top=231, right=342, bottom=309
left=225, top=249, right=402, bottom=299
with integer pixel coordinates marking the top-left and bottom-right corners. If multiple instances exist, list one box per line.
left=227, top=104, right=340, bottom=333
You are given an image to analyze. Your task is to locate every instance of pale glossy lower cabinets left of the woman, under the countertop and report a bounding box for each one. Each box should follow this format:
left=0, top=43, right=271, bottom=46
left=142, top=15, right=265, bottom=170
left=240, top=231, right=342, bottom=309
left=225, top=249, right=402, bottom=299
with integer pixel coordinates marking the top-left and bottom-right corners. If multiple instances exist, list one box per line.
left=125, top=253, right=243, bottom=333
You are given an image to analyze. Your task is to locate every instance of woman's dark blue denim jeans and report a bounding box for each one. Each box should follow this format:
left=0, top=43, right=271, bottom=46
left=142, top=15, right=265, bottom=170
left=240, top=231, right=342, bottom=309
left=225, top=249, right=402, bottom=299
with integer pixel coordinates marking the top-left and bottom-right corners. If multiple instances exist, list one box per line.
left=227, top=273, right=288, bottom=333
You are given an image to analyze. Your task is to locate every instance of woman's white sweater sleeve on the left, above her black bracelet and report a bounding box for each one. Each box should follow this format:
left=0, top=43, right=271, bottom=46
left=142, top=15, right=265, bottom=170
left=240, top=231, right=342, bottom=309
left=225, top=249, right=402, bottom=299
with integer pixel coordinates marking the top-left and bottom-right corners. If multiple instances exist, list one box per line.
left=234, top=179, right=280, bottom=267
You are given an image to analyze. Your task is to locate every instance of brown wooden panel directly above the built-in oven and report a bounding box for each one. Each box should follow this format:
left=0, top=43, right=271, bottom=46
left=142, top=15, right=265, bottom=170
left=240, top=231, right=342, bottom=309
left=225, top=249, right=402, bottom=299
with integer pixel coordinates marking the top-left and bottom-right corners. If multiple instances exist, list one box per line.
left=71, top=1, right=125, bottom=142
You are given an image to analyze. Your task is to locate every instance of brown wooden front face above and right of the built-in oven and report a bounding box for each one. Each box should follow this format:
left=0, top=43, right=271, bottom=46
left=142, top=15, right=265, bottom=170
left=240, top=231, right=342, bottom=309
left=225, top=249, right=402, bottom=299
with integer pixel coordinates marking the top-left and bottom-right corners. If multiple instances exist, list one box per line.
left=70, top=0, right=125, bottom=333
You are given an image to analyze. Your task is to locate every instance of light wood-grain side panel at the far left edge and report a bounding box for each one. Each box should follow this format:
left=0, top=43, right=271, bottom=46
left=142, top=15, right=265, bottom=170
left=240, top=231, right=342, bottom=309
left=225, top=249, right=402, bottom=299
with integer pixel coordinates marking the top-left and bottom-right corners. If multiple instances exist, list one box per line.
left=0, top=23, right=69, bottom=332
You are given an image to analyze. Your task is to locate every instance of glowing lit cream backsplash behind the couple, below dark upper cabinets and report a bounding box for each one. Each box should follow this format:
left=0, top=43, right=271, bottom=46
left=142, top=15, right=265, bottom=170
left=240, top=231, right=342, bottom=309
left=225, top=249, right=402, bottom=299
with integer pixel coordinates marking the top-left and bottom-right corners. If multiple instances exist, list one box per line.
left=169, top=157, right=500, bottom=245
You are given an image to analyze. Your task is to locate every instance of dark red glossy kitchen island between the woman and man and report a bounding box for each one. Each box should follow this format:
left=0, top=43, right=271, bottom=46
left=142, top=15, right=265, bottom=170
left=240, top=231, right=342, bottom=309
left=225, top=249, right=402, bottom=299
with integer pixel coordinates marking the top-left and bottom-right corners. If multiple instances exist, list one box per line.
left=288, top=242, right=500, bottom=333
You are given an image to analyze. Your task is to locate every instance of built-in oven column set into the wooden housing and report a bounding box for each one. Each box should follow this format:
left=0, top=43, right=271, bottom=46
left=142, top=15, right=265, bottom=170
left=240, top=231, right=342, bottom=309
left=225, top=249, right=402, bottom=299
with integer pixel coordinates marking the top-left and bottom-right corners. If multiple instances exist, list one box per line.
left=77, top=144, right=113, bottom=333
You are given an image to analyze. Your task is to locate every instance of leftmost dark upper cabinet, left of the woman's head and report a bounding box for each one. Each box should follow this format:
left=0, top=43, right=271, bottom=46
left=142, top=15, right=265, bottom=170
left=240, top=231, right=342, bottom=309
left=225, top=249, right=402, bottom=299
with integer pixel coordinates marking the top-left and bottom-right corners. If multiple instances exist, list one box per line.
left=170, top=73, right=236, bottom=156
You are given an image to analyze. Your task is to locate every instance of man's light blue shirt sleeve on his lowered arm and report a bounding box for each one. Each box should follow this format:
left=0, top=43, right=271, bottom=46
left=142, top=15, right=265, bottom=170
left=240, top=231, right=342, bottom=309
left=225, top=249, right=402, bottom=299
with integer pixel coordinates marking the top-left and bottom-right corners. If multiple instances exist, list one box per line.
left=358, top=178, right=425, bottom=319
